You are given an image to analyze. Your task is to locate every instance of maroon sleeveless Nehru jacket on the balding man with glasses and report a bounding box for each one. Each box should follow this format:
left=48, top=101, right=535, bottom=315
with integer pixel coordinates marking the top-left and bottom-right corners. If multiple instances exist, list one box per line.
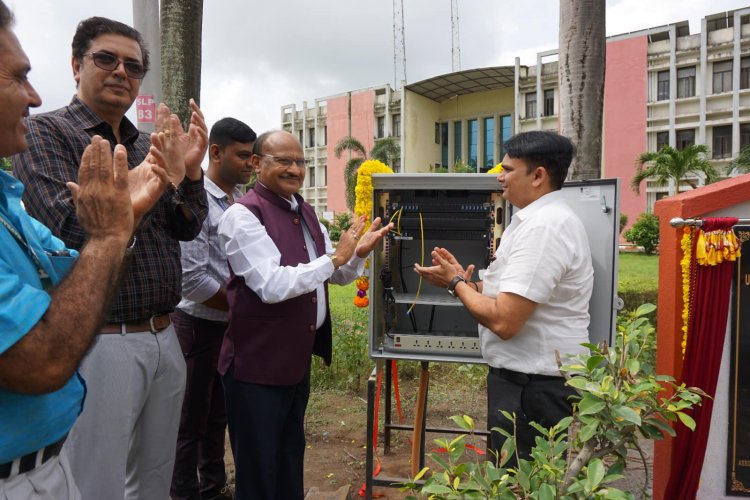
left=219, top=182, right=332, bottom=385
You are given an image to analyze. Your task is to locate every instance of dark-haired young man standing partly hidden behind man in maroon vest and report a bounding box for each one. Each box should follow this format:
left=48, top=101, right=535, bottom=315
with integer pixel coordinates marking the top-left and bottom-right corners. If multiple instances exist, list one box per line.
left=169, top=118, right=256, bottom=500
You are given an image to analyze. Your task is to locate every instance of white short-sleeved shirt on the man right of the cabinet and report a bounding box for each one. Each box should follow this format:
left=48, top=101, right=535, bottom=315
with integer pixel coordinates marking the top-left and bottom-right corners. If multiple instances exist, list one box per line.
left=479, top=191, right=594, bottom=376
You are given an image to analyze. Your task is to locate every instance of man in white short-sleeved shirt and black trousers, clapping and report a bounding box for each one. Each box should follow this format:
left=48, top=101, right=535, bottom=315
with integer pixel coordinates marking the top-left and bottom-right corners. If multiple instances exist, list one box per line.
left=414, top=131, right=594, bottom=464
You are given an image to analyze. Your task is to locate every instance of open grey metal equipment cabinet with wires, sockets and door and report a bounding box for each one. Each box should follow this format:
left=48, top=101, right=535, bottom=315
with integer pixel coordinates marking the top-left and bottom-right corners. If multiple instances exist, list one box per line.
left=368, top=174, right=619, bottom=363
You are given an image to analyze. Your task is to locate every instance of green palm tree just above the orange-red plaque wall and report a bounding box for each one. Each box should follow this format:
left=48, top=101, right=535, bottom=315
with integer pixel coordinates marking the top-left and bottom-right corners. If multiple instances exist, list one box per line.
left=630, top=144, right=719, bottom=195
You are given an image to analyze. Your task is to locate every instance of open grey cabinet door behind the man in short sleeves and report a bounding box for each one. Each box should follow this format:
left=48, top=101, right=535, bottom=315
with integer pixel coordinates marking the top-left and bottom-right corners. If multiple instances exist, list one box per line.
left=506, top=179, right=621, bottom=345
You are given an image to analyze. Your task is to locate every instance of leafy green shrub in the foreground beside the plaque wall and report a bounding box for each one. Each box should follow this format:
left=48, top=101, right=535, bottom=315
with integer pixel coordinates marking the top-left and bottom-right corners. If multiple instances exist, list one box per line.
left=401, top=304, right=708, bottom=500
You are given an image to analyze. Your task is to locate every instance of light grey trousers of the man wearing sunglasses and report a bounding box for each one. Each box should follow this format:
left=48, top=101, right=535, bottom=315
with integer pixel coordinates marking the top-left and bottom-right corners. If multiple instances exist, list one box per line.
left=64, top=325, right=185, bottom=500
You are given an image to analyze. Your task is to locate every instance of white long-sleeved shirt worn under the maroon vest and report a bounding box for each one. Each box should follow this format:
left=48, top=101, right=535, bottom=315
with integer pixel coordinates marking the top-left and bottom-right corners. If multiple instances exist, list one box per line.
left=219, top=188, right=365, bottom=328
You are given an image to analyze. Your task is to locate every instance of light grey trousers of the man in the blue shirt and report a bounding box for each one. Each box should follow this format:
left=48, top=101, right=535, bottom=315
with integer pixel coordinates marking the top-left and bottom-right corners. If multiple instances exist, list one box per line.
left=0, top=452, right=81, bottom=500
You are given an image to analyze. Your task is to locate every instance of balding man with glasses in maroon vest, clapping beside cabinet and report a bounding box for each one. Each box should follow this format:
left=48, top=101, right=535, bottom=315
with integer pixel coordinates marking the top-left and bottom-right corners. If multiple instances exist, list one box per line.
left=219, top=131, right=391, bottom=500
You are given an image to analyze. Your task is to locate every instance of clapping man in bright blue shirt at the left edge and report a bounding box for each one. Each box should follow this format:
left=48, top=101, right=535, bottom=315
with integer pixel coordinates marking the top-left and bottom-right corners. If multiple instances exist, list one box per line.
left=0, top=0, right=185, bottom=499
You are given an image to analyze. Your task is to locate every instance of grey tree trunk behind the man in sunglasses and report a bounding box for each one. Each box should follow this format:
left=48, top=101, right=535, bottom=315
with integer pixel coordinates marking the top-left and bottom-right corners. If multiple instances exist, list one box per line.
left=161, top=0, right=203, bottom=127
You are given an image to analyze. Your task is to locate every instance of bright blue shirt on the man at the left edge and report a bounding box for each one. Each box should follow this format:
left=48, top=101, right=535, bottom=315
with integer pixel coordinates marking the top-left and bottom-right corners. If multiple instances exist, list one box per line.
left=0, top=172, right=85, bottom=463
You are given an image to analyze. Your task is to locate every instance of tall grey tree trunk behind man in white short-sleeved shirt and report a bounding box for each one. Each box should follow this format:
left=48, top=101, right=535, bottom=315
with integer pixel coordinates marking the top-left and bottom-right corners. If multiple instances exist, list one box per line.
left=558, top=0, right=606, bottom=179
